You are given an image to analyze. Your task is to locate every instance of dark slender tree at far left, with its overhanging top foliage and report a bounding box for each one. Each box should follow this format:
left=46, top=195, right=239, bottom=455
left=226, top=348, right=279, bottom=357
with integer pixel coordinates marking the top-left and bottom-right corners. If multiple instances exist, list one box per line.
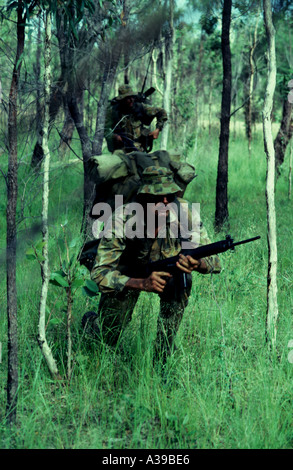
left=1, top=0, right=96, bottom=424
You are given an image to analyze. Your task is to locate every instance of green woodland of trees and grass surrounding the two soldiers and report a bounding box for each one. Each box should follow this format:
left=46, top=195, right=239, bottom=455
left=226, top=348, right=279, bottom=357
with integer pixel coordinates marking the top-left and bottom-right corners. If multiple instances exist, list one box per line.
left=0, top=0, right=293, bottom=449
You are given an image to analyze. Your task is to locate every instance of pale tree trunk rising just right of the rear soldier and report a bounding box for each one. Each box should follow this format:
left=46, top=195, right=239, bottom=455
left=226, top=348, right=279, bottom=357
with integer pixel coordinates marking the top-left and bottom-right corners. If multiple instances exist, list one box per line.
left=161, top=0, right=174, bottom=150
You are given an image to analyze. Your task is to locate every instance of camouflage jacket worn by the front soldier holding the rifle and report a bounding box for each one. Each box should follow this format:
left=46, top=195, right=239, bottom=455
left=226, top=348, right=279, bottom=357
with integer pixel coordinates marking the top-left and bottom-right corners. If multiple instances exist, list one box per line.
left=91, top=198, right=221, bottom=293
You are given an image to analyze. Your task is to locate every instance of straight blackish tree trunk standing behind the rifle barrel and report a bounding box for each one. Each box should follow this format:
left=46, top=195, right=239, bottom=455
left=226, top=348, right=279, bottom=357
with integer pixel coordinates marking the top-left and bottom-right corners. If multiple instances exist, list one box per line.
left=215, top=0, right=232, bottom=230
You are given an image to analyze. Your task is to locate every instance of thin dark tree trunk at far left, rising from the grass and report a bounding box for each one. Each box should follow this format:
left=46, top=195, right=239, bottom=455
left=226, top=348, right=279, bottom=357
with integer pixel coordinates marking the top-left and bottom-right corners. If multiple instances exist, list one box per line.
left=6, top=0, right=25, bottom=424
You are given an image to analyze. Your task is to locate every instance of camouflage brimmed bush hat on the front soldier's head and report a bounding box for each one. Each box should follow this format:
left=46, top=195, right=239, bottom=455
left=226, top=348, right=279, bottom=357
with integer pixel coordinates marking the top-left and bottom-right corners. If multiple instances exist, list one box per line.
left=138, top=166, right=181, bottom=196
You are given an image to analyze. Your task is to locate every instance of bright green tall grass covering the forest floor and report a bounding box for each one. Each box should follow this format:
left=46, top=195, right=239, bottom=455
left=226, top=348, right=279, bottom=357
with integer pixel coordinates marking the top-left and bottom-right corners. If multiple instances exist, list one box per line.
left=0, top=126, right=293, bottom=449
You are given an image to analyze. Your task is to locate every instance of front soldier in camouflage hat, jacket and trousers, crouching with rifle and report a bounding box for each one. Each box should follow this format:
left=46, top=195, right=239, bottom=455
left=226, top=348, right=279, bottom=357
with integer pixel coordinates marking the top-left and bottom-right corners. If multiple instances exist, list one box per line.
left=83, top=166, right=221, bottom=361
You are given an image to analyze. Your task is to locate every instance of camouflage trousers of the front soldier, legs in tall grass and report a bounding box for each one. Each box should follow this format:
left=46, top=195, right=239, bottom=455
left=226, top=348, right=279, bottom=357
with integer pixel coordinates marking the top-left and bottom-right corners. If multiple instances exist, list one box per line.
left=93, top=288, right=190, bottom=360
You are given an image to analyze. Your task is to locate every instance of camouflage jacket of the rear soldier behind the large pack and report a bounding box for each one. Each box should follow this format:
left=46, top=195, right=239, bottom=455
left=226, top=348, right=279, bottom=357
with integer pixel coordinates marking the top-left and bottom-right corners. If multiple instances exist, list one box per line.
left=105, top=101, right=167, bottom=152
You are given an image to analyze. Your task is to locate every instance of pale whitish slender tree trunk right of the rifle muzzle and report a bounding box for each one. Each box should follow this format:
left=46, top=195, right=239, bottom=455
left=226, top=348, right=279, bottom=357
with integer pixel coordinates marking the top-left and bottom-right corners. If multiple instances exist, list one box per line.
left=263, top=0, right=278, bottom=350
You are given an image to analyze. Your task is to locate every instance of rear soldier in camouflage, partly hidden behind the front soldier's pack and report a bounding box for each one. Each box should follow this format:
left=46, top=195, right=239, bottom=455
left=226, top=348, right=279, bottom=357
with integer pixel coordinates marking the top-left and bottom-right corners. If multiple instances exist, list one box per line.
left=105, top=85, right=167, bottom=153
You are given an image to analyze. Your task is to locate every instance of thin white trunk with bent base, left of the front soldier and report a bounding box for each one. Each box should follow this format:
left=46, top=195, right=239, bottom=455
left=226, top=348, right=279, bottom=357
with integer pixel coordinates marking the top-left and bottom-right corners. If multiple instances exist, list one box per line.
left=38, top=11, right=59, bottom=378
